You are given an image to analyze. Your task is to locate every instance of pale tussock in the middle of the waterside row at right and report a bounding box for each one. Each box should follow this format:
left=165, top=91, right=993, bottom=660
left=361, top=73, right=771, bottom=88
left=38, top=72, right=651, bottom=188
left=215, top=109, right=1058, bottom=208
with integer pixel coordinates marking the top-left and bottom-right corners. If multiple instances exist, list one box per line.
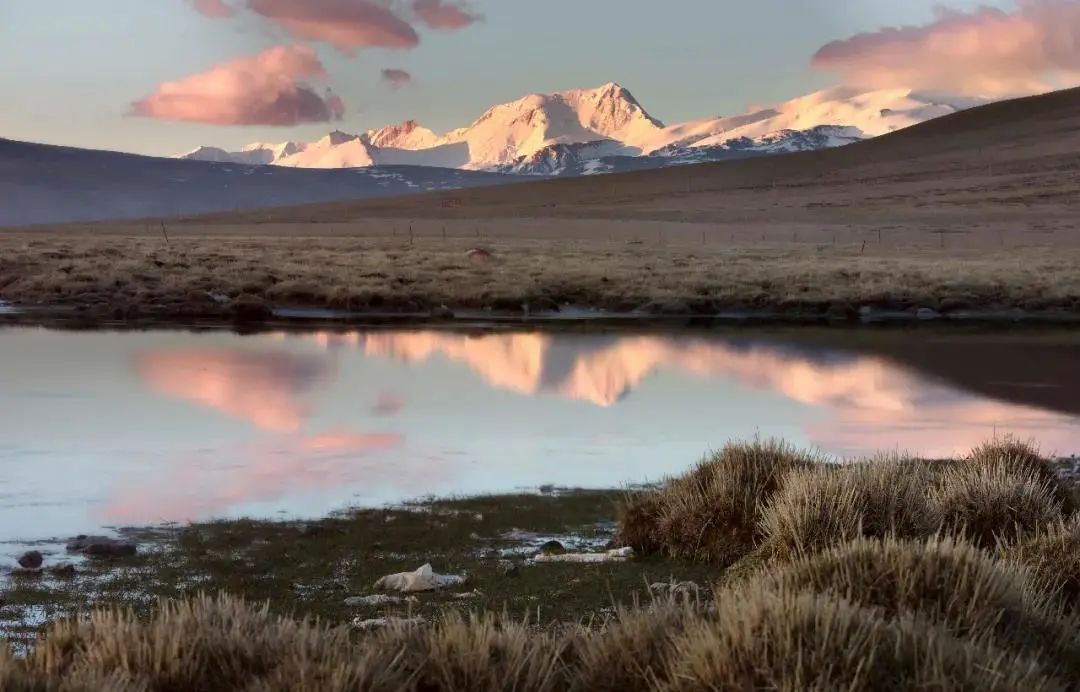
left=760, top=457, right=939, bottom=559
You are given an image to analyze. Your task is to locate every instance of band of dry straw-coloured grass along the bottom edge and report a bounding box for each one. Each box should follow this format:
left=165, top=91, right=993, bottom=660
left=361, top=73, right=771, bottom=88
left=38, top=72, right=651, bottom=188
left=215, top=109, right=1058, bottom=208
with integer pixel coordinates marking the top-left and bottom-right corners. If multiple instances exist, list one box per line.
left=0, top=586, right=1062, bottom=692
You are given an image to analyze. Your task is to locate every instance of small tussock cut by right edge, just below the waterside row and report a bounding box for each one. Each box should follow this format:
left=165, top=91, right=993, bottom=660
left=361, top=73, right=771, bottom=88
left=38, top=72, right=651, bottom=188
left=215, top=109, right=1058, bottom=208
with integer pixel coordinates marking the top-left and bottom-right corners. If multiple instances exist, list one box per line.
left=1007, top=516, right=1080, bottom=610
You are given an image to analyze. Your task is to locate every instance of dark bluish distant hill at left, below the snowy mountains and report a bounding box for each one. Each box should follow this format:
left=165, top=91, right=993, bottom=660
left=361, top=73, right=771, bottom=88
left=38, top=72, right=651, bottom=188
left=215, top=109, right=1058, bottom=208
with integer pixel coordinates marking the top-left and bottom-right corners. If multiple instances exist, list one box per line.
left=0, top=139, right=519, bottom=226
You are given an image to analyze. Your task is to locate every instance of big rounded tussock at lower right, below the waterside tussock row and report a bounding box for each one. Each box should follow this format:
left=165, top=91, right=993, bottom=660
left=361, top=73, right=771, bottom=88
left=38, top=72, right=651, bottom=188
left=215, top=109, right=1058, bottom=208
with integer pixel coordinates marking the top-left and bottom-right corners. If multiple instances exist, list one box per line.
left=764, top=537, right=1080, bottom=671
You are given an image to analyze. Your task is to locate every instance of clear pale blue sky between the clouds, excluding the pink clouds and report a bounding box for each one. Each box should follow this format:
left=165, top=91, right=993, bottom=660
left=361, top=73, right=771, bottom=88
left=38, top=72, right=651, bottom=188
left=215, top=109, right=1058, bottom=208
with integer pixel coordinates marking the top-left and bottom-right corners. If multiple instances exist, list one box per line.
left=0, top=0, right=1011, bottom=154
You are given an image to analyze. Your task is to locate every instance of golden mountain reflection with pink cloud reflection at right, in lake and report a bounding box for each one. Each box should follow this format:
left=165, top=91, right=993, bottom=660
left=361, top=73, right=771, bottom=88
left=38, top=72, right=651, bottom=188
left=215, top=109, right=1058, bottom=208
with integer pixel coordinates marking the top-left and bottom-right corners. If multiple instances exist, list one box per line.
left=315, top=333, right=1080, bottom=457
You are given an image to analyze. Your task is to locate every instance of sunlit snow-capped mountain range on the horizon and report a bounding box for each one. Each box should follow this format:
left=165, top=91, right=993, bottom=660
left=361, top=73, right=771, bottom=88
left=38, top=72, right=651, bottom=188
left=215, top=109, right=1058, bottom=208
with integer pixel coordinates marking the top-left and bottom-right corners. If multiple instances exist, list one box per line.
left=180, top=83, right=982, bottom=176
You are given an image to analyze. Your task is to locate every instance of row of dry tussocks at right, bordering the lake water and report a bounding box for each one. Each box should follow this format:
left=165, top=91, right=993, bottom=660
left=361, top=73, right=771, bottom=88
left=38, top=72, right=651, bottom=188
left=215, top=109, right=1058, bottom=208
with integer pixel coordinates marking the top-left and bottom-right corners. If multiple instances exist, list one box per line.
left=619, top=440, right=1071, bottom=565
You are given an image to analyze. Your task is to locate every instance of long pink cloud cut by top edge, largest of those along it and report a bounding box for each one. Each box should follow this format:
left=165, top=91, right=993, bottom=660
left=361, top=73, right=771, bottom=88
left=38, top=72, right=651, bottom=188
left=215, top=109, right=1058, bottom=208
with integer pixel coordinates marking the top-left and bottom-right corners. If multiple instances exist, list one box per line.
left=248, top=0, right=420, bottom=54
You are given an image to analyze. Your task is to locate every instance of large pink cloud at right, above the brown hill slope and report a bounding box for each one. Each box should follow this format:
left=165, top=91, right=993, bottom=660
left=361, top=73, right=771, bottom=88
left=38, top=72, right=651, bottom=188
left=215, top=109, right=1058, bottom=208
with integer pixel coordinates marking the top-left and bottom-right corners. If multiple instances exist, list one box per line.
left=811, top=0, right=1080, bottom=97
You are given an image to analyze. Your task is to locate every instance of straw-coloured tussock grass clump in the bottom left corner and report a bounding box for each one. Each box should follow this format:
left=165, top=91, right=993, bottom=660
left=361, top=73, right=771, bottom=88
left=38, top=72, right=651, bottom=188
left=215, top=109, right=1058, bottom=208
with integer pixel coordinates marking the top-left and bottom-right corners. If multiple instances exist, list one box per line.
left=26, top=597, right=400, bottom=692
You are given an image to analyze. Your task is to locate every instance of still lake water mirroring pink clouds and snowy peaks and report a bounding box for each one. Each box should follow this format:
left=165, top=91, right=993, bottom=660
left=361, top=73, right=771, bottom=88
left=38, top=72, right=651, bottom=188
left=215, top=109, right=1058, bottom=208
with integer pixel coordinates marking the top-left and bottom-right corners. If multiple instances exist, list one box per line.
left=0, top=328, right=1080, bottom=548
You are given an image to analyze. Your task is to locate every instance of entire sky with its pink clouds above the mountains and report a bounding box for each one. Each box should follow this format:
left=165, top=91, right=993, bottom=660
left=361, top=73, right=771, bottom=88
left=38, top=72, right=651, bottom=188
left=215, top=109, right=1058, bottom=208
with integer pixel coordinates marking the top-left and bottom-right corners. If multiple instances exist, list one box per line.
left=0, top=0, right=1080, bottom=155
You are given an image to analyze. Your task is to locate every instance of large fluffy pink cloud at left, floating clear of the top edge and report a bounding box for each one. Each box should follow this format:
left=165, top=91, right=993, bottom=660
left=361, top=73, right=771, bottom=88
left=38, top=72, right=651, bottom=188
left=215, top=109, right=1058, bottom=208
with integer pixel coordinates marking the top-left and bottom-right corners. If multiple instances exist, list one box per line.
left=131, top=45, right=345, bottom=126
